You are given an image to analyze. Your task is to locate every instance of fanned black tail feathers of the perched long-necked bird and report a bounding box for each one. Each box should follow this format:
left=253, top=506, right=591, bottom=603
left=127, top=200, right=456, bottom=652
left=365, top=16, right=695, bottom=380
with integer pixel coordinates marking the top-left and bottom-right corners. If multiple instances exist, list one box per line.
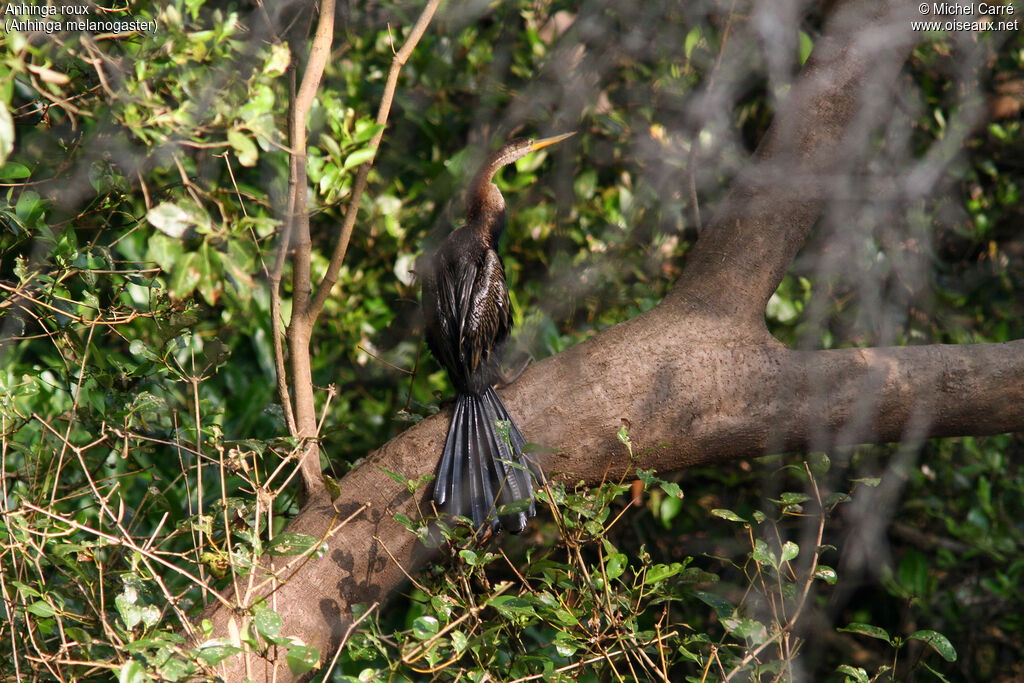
left=434, top=387, right=543, bottom=533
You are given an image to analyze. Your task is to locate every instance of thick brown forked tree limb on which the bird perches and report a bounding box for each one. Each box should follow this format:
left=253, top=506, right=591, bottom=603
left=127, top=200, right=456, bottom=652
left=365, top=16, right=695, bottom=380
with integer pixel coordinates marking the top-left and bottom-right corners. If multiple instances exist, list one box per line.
left=206, top=2, right=1024, bottom=680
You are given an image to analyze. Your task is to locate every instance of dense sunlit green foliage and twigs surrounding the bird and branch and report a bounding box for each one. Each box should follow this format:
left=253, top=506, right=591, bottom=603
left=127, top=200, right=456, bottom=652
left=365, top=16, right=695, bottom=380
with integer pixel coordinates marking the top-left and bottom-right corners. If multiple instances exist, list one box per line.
left=0, top=0, right=1024, bottom=681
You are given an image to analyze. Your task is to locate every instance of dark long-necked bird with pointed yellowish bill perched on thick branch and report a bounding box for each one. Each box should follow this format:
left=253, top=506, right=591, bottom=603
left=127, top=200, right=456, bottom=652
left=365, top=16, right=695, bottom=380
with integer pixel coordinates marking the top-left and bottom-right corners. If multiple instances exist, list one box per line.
left=423, top=133, right=572, bottom=533
